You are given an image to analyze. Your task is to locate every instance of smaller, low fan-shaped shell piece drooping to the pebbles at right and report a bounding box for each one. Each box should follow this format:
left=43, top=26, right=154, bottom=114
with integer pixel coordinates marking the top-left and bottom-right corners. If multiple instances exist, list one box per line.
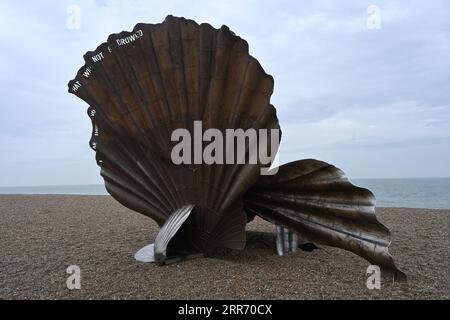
left=244, top=159, right=406, bottom=281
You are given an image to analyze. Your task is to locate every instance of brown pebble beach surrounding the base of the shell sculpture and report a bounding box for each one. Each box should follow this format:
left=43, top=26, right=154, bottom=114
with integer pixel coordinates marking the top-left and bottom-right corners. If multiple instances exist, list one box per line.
left=0, top=195, right=450, bottom=299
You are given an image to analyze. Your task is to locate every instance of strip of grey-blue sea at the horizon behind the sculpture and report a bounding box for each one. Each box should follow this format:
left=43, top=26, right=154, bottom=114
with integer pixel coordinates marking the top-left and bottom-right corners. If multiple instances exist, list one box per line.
left=0, top=178, right=450, bottom=209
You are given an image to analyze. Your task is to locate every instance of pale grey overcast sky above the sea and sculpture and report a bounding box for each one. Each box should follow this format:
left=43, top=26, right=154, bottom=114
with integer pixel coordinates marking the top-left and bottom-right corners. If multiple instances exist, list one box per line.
left=0, top=0, right=450, bottom=186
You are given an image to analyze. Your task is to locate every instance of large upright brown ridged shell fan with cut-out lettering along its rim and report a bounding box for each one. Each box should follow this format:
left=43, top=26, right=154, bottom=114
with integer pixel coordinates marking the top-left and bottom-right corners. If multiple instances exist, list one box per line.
left=69, top=16, right=279, bottom=251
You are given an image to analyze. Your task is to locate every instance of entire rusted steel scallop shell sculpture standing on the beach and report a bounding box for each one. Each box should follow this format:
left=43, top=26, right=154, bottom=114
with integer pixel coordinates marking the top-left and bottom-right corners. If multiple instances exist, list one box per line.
left=69, top=16, right=403, bottom=278
